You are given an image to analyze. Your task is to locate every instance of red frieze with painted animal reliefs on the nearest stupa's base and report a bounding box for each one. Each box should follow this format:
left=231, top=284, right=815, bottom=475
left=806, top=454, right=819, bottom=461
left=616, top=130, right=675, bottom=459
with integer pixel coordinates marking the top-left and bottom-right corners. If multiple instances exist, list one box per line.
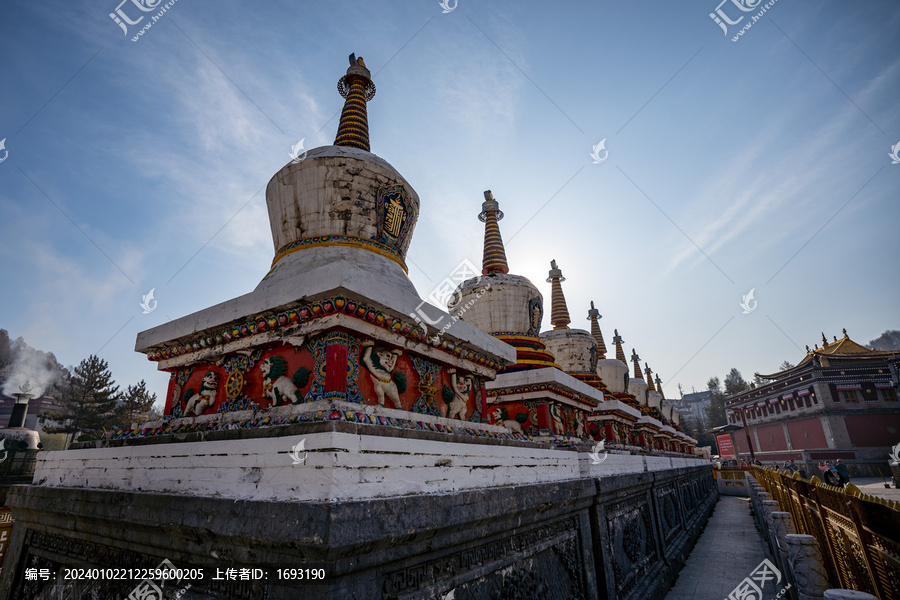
left=164, top=330, right=486, bottom=422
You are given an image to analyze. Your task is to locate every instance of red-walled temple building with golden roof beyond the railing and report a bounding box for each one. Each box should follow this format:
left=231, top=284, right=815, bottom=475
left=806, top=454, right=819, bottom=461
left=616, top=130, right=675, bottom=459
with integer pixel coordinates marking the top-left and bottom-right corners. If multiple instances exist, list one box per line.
left=725, top=329, right=900, bottom=476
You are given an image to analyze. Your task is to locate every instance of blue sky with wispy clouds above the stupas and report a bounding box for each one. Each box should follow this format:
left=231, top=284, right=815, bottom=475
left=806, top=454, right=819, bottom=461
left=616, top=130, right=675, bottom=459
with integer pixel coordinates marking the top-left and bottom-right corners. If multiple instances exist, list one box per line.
left=0, top=0, right=900, bottom=408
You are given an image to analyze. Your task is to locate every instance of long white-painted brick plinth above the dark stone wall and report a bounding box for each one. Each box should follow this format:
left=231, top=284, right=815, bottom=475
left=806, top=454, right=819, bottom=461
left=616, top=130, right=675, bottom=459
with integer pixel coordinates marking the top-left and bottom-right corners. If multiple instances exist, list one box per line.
left=34, top=431, right=707, bottom=501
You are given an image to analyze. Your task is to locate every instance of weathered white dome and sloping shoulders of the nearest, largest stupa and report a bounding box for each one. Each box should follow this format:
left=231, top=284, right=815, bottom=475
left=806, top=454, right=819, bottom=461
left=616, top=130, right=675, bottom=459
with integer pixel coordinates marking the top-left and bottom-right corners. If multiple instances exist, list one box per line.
left=135, top=146, right=512, bottom=375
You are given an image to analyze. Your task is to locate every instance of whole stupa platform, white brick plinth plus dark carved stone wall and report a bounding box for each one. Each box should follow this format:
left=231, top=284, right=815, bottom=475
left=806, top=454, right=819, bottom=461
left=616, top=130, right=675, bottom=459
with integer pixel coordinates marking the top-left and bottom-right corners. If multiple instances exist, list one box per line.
left=0, top=422, right=717, bottom=600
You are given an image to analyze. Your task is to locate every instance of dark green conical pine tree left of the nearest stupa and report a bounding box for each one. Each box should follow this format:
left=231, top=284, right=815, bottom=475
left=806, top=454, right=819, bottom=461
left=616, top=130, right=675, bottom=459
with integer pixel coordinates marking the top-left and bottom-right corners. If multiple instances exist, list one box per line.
left=41, top=354, right=121, bottom=433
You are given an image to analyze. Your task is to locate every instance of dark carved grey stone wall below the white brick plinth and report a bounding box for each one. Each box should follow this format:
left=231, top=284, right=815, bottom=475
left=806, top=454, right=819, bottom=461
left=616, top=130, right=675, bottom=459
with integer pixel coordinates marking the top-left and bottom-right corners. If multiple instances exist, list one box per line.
left=0, top=466, right=717, bottom=600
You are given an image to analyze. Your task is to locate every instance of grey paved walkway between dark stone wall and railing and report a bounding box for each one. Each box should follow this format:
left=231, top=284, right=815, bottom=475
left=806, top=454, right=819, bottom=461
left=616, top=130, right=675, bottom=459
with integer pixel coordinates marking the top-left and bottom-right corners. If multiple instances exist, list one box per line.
left=665, top=496, right=768, bottom=600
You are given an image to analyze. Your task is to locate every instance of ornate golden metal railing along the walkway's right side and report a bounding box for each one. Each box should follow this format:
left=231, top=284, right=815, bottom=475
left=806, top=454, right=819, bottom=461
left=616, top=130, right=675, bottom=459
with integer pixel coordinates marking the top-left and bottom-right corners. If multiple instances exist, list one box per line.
left=752, top=467, right=900, bottom=600
